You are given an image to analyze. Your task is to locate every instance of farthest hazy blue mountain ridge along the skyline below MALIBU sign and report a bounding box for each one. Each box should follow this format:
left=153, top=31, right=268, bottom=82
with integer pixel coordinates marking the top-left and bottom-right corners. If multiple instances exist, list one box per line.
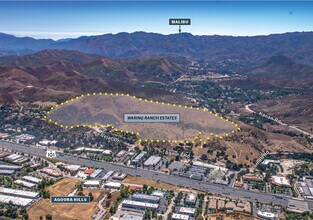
left=0, top=32, right=313, bottom=65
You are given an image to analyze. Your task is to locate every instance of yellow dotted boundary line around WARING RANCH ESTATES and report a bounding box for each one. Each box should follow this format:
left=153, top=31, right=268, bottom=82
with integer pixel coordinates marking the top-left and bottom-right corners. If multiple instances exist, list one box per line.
left=43, top=92, right=240, bottom=145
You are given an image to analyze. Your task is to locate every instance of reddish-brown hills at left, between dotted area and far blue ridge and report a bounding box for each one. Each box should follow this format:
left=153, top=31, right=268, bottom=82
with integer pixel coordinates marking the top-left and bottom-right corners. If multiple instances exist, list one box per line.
left=0, top=50, right=187, bottom=103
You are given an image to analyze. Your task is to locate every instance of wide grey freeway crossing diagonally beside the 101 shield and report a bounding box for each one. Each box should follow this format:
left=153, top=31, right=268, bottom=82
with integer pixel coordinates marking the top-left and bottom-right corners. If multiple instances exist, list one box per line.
left=0, top=141, right=313, bottom=211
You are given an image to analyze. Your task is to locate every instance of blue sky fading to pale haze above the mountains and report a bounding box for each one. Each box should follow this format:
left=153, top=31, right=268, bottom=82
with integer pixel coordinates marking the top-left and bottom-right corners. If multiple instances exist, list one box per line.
left=0, top=1, right=313, bottom=39
